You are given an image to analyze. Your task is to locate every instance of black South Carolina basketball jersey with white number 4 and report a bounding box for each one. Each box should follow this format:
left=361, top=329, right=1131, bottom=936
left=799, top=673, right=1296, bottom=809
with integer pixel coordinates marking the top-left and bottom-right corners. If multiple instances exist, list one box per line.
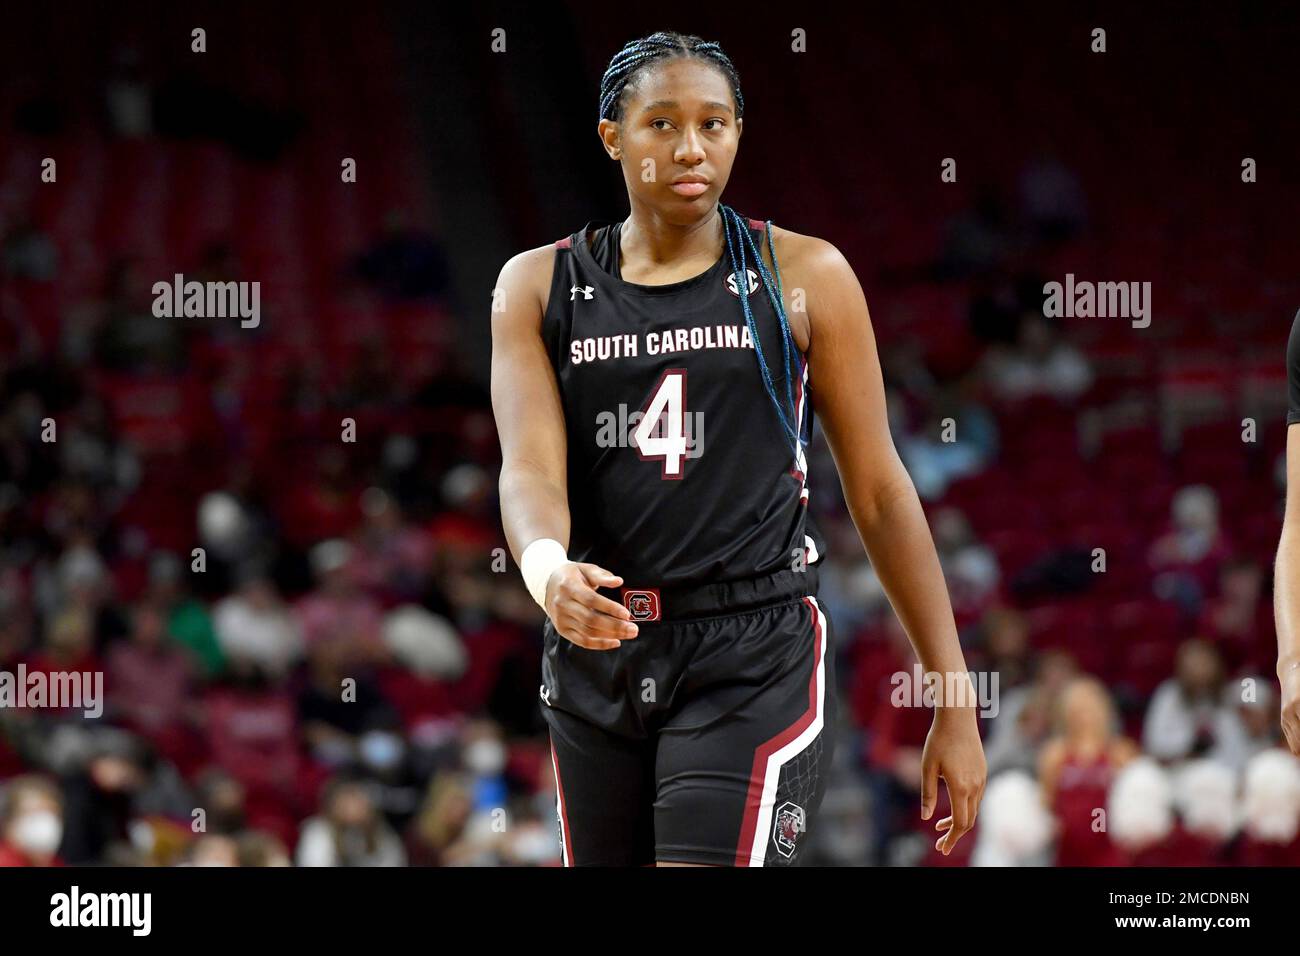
left=542, top=220, right=826, bottom=585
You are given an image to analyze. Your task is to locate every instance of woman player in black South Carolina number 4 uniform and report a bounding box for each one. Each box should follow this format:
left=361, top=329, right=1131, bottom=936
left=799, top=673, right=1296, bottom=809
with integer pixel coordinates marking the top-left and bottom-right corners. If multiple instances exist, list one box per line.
left=491, top=33, right=985, bottom=866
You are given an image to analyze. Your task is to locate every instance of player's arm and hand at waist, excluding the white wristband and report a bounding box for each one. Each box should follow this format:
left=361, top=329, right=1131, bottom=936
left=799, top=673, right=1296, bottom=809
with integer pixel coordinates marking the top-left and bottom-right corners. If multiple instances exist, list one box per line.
left=491, top=246, right=636, bottom=650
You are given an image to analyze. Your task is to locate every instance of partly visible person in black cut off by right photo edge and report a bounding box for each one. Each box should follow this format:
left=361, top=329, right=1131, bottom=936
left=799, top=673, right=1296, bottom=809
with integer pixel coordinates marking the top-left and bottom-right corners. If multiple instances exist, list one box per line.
left=1273, top=312, right=1300, bottom=756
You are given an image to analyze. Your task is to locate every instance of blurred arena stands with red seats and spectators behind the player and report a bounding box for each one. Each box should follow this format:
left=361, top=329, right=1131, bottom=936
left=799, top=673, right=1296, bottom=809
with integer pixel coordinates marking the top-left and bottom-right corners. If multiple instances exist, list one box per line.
left=0, top=3, right=1300, bottom=866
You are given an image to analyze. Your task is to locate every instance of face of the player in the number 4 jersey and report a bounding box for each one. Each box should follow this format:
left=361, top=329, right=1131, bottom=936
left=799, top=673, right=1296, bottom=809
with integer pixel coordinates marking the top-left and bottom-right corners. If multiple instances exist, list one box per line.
left=602, top=59, right=741, bottom=222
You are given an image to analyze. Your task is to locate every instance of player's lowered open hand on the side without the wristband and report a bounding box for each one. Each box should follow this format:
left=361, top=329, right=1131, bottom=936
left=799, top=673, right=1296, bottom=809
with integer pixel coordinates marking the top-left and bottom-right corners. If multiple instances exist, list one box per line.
left=920, top=706, right=988, bottom=856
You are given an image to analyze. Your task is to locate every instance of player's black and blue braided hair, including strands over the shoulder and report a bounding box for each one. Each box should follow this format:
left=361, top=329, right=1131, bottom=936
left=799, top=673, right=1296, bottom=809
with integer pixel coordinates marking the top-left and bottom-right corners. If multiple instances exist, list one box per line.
left=599, top=31, right=807, bottom=460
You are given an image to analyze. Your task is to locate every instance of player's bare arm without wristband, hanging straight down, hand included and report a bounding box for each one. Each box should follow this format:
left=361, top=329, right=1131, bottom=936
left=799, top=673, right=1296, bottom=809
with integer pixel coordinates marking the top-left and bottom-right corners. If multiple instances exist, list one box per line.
left=777, top=237, right=987, bottom=855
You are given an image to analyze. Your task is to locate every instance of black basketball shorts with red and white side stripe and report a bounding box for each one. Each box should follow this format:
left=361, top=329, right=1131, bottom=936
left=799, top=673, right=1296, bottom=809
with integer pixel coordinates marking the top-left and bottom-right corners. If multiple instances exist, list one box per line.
left=540, top=566, right=837, bottom=866
